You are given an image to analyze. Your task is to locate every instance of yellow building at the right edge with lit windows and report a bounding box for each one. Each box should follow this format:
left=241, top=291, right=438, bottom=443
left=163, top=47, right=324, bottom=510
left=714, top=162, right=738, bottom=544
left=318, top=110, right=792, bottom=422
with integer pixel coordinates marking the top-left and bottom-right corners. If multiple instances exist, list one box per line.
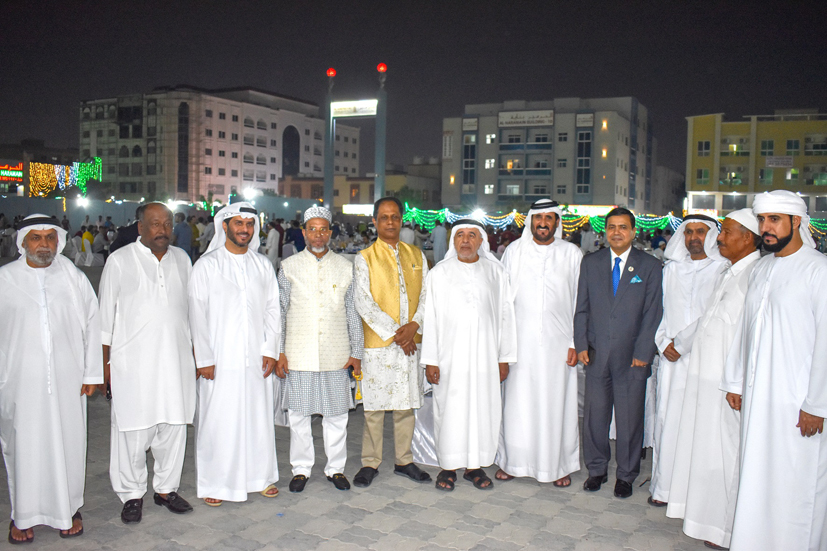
left=686, top=109, right=827, bottom=214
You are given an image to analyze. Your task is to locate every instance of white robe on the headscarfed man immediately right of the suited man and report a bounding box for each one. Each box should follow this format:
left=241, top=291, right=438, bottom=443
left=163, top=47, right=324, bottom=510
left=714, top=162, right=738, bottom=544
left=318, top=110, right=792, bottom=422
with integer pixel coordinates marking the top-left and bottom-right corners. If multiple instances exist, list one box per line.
left=649, top=257, right=728, bottom=502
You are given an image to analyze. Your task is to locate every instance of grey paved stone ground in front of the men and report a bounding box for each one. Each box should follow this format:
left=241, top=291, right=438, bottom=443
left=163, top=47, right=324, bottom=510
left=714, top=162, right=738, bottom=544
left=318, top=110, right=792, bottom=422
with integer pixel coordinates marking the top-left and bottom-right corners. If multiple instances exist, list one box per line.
left=0, top=394, right=704, bottom=551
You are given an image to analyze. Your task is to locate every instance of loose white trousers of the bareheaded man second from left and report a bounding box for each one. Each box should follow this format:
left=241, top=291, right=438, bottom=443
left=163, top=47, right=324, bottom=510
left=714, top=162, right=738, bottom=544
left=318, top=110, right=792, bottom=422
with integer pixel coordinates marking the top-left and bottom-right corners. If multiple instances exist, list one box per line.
left=109, top=414, right=187, bottom=503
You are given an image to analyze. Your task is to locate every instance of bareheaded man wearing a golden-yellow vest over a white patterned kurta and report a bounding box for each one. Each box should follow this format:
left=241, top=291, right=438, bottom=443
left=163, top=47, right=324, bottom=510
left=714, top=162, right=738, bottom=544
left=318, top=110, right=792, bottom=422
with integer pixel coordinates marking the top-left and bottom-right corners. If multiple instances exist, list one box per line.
left=353, top=197, right=431, bottom=487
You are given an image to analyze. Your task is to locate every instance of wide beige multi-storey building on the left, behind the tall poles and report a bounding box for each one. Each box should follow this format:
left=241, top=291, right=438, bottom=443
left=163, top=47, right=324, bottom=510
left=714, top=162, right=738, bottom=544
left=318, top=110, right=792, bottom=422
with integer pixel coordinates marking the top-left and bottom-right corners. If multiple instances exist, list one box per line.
left=79, top=85, right=359, bottom=201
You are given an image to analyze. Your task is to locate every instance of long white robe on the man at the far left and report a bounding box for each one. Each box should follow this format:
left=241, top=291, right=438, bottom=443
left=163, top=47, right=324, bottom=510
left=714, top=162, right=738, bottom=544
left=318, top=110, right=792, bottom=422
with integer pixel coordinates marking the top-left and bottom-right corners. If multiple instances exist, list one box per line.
left=0, top=255, right=103, bottom=530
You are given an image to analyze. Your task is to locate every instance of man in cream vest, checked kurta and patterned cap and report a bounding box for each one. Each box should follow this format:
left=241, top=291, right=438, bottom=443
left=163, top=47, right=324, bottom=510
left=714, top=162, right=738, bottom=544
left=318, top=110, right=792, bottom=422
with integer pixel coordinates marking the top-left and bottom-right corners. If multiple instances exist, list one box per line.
left=276, top=206, right=363, bottom=492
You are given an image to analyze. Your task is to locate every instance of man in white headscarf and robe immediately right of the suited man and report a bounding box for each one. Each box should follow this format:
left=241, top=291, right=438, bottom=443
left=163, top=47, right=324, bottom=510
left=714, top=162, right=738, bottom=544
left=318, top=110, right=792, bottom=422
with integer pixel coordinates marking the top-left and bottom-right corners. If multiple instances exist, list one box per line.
left=649, top=214, right=726, bottom=507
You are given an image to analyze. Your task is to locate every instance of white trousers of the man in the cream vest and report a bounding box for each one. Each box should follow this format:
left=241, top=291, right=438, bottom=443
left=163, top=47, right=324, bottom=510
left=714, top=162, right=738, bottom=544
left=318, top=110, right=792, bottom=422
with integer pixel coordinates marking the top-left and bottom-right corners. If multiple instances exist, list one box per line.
left=288, top=410, right=347, bottom=477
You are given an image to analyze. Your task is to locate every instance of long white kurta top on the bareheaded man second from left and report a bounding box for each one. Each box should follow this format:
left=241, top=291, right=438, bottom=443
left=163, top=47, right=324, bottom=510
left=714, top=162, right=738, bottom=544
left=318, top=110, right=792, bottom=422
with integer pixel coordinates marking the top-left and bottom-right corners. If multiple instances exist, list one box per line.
left=100, top=241, right=195, bottom=431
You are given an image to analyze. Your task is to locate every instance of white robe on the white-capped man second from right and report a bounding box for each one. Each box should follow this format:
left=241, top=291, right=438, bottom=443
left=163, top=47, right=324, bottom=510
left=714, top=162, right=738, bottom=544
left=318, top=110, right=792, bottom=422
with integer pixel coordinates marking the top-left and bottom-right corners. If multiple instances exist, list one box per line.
left=666, top=251, right=761, bottom=547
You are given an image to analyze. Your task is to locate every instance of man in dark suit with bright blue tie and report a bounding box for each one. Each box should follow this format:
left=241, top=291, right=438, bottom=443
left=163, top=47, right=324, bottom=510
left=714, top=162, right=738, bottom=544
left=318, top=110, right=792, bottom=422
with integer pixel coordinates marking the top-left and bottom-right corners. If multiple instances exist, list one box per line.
left=574, top=208, right=663, bottom=498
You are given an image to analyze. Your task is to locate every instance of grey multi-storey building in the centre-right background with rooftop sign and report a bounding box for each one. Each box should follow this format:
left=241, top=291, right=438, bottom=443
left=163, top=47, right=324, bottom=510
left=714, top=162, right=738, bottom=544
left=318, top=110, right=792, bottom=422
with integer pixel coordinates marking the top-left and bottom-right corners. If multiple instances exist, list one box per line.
left=442, top=97, right=657, bottom=212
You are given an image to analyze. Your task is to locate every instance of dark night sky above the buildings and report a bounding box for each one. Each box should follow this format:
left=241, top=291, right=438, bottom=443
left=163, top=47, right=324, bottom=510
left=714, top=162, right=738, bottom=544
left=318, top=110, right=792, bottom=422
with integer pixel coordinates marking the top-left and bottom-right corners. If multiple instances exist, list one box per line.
left=0, top=0, right=827, bottom=173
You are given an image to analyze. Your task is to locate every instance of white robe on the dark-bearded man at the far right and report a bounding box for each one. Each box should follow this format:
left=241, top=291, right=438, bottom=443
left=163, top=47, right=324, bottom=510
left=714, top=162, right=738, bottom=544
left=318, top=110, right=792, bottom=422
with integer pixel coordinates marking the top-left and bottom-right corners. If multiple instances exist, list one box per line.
left=721, top=246, right=827, bottom=551
